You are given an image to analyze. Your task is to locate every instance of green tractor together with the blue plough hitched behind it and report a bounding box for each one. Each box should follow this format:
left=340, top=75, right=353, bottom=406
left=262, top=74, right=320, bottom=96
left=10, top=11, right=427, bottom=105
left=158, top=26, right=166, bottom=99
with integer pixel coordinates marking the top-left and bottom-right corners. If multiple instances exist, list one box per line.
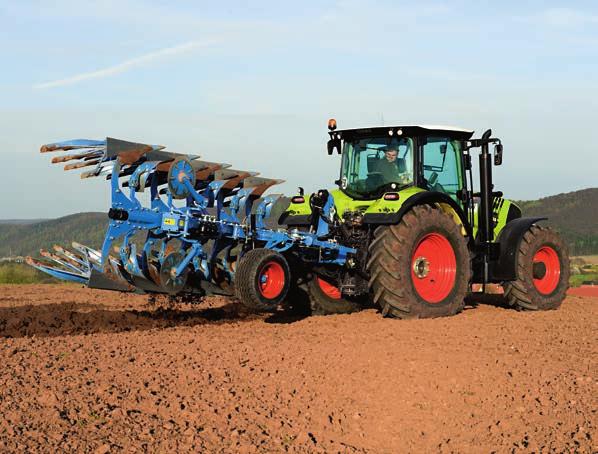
left=27, top=119, right=569, bottom=319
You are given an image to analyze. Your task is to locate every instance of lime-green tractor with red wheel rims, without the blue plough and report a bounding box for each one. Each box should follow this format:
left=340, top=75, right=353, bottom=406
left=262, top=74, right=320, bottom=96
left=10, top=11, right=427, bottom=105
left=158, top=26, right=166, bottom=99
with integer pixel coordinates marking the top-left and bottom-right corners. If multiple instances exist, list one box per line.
left=279, top=119, right=569, bottom=319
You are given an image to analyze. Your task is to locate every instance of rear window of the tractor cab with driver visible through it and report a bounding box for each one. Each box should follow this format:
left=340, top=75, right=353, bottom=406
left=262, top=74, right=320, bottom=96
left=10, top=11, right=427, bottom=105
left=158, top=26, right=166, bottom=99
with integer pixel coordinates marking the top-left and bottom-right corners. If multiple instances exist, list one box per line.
left=341, top=136, right=413, bottom=197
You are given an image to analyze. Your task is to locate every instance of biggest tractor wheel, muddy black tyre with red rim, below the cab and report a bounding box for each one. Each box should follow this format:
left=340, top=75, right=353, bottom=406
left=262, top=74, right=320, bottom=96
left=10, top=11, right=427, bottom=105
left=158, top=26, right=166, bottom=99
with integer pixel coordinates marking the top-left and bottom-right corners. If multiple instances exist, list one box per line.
left=367, top=205, right=471, bottom=319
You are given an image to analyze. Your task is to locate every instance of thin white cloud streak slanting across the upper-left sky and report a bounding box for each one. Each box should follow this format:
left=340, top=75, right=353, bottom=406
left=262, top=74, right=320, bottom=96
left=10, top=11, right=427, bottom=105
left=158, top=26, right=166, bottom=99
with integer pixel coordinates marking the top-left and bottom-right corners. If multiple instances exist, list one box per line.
left=33, top=40, right=215, bottom=89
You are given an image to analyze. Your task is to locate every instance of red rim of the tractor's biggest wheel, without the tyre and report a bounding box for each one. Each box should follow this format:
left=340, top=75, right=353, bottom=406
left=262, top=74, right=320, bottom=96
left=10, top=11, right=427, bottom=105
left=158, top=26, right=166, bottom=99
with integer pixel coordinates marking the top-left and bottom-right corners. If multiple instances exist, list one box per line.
left=411, top=233, right=457, bottom=303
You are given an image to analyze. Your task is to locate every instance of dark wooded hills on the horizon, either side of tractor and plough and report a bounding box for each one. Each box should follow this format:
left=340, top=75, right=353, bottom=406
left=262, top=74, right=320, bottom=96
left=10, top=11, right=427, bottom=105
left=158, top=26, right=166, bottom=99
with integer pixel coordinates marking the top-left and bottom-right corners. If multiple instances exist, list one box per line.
left=0, top=188, right=598, bottom=257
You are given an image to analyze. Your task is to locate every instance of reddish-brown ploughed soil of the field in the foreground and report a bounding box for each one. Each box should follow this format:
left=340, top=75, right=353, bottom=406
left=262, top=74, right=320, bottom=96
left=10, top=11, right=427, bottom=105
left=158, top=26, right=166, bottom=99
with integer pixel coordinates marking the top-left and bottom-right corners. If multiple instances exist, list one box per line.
left=0, top=285, right=598, bottom=453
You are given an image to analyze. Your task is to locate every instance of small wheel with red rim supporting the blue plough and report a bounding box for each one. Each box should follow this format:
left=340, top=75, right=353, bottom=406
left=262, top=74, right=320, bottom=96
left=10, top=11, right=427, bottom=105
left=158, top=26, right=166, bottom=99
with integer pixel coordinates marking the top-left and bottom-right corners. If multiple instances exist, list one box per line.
left=234, top=248, right=291, bottom=312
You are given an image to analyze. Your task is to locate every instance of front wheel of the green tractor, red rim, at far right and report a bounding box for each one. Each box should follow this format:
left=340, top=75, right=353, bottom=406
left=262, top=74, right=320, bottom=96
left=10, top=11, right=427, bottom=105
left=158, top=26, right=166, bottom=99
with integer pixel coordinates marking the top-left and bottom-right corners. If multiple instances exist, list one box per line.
left=504, top=225, right=570, bottom=311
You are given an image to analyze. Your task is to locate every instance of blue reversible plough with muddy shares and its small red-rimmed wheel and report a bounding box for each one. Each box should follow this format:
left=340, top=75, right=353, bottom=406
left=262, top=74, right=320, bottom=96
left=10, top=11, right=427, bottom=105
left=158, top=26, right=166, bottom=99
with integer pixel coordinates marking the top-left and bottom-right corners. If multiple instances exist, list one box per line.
left=27, top=138, right=356, bottom=308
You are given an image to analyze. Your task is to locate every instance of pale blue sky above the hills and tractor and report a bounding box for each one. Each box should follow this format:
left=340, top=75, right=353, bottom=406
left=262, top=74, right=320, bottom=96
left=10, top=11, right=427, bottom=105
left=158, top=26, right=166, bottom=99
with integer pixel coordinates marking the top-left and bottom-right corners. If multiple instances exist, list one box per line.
left=0, top=0, right=598, bottom=219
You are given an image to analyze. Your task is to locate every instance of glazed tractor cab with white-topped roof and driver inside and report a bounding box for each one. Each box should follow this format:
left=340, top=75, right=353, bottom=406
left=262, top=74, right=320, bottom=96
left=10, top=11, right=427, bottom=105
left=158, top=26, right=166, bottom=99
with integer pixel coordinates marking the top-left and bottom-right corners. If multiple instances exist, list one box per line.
left=328, top=122, right=473, bottom=202
